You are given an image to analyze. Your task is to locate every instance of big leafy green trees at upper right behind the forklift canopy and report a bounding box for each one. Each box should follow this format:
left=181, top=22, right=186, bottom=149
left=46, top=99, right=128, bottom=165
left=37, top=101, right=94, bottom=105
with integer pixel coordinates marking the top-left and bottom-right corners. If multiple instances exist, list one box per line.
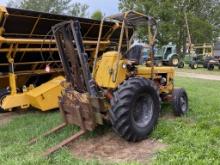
left=119, top=0, right=220, bottom=52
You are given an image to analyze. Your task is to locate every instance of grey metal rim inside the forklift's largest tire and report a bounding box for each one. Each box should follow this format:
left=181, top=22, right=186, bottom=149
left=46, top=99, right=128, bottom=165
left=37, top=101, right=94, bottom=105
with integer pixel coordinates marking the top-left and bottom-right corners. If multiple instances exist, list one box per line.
left=132, top=95, right=154, bottom=127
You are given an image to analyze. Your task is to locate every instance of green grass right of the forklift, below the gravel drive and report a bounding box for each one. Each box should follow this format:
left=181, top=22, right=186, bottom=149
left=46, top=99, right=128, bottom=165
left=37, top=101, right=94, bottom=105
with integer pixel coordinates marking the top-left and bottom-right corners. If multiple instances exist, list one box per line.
left=152, top=78, right=220, bottom=165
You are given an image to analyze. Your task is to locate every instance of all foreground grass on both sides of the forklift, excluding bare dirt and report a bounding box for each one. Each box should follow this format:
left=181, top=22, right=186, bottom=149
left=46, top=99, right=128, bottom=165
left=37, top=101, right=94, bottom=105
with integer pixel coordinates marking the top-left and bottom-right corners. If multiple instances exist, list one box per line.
left=0, top=78, right=220, bottom=165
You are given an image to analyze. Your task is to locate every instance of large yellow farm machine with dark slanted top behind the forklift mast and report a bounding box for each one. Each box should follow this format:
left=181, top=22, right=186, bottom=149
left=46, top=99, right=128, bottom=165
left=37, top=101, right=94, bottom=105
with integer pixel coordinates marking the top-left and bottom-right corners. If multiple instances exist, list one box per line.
left=0, top=6, right=125, bottom=111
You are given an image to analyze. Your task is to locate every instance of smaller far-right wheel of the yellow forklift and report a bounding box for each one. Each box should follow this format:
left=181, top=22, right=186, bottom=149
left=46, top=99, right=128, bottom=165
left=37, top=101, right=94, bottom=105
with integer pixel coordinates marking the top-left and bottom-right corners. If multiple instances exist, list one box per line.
left=172, top=88, right=189, bottom=116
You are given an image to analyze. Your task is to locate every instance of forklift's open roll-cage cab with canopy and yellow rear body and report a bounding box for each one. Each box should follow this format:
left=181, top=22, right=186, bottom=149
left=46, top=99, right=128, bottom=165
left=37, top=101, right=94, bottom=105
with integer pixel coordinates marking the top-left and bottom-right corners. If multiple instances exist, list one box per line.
left=93, top=11, right=163, bottom=88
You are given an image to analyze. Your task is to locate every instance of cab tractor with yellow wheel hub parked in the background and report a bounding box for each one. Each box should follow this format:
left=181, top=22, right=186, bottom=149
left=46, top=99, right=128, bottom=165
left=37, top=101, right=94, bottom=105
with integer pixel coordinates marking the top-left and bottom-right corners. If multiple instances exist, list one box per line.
left=155, top=42, right=184, bottom=68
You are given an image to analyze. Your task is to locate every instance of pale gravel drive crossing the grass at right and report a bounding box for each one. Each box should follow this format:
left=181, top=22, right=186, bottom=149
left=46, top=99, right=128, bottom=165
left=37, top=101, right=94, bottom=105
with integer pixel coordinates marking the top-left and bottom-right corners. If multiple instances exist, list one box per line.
left=176, top=72, right=220, bottom=81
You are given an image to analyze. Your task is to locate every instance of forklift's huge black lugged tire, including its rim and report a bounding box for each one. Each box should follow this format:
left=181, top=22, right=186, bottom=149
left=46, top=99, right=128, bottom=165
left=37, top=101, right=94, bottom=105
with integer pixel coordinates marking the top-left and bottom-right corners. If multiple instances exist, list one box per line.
left=110, top=77, right=160, bottom=142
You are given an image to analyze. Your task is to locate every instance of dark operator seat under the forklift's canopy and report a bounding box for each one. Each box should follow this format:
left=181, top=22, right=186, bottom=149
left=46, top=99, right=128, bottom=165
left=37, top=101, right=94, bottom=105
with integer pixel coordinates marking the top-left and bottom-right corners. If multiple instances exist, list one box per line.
left=124, top=45, right=144, bottom=65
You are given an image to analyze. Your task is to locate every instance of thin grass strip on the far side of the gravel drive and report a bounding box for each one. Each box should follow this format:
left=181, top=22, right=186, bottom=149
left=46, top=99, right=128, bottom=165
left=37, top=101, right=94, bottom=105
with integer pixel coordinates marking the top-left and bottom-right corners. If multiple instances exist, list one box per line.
left=175, top=66, right=220, bottom=76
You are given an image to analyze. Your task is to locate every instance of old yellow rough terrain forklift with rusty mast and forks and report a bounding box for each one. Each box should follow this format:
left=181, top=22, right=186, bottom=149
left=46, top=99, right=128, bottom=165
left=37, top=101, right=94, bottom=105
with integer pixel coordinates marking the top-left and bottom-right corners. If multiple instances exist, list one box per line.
left=32, top=11, right=188, bottom=155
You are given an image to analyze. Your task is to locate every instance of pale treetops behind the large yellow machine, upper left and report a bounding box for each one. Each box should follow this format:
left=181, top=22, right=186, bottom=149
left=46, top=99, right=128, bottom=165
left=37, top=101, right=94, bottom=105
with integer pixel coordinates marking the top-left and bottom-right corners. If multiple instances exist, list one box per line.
left=7, top=0, right=88, bottom=17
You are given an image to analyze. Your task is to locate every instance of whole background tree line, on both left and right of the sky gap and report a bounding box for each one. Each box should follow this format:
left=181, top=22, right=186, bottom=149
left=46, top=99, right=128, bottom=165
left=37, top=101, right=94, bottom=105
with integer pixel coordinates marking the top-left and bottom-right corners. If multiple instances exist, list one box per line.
left=8, top=0, right=220, bottom=52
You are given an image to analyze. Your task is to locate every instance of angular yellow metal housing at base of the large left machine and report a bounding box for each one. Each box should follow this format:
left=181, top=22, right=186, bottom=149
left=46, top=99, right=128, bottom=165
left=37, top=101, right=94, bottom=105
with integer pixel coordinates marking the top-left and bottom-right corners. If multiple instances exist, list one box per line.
left=1, top=76, right=65, bottom=111
